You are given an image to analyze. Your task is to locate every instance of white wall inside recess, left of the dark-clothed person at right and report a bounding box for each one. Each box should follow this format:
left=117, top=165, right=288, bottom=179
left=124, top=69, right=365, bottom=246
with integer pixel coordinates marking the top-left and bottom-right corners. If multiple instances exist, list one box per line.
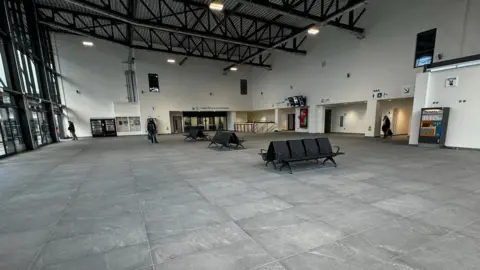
left=329, top=103, right=367, bottom=134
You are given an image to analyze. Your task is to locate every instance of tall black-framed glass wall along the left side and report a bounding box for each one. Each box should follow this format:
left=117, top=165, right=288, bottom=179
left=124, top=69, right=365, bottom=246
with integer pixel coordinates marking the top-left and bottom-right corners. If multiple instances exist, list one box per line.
left=0, top=0, right=62, bottom=157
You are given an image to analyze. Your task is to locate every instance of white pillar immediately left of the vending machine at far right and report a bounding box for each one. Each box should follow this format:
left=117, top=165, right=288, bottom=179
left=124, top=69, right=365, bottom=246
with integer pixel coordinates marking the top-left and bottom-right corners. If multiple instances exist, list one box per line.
left=408, top=72, right=430, bottom=145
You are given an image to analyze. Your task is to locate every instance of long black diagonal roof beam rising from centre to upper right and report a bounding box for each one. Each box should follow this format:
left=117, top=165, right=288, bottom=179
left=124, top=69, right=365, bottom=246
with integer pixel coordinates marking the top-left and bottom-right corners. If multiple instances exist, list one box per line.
left=223, top=0, right=366, bottom=72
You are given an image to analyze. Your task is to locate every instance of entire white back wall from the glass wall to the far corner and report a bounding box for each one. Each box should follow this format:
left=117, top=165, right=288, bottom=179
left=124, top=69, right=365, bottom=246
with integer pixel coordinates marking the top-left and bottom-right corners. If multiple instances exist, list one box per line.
left=55, top=34, right=252, bottom=136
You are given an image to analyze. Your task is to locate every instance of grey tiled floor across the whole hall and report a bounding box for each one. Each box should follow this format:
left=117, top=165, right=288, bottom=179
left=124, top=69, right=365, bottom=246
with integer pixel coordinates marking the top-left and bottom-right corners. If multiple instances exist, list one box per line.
left=0, top=133, right=480, bottom=270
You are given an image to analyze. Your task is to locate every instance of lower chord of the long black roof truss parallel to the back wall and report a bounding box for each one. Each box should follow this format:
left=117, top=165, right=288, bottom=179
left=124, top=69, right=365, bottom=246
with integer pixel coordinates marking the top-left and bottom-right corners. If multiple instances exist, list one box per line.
left=39, top=20, right=272, bottom=69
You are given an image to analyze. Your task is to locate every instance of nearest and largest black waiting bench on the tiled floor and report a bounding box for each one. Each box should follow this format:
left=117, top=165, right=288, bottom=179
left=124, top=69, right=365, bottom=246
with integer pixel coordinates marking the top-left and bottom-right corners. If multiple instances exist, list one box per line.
left=259, top=138, right=345, bottom=173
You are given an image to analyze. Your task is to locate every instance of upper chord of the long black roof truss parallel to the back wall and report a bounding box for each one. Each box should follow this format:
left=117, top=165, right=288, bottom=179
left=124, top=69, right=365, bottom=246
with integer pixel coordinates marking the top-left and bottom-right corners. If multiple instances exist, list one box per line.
left=58, top=0, right=306, bottom=55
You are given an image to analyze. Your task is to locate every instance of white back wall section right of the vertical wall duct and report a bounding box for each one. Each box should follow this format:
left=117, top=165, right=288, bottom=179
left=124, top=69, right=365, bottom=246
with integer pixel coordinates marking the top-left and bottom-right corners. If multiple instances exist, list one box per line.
left=135, top=51, right=252, bottom=133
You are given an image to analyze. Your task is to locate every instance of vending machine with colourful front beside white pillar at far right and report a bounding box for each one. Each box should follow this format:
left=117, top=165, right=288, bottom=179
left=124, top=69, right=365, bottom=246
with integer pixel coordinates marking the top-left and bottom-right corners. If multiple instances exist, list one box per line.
left=418, top=107, right=450, bottom=148
